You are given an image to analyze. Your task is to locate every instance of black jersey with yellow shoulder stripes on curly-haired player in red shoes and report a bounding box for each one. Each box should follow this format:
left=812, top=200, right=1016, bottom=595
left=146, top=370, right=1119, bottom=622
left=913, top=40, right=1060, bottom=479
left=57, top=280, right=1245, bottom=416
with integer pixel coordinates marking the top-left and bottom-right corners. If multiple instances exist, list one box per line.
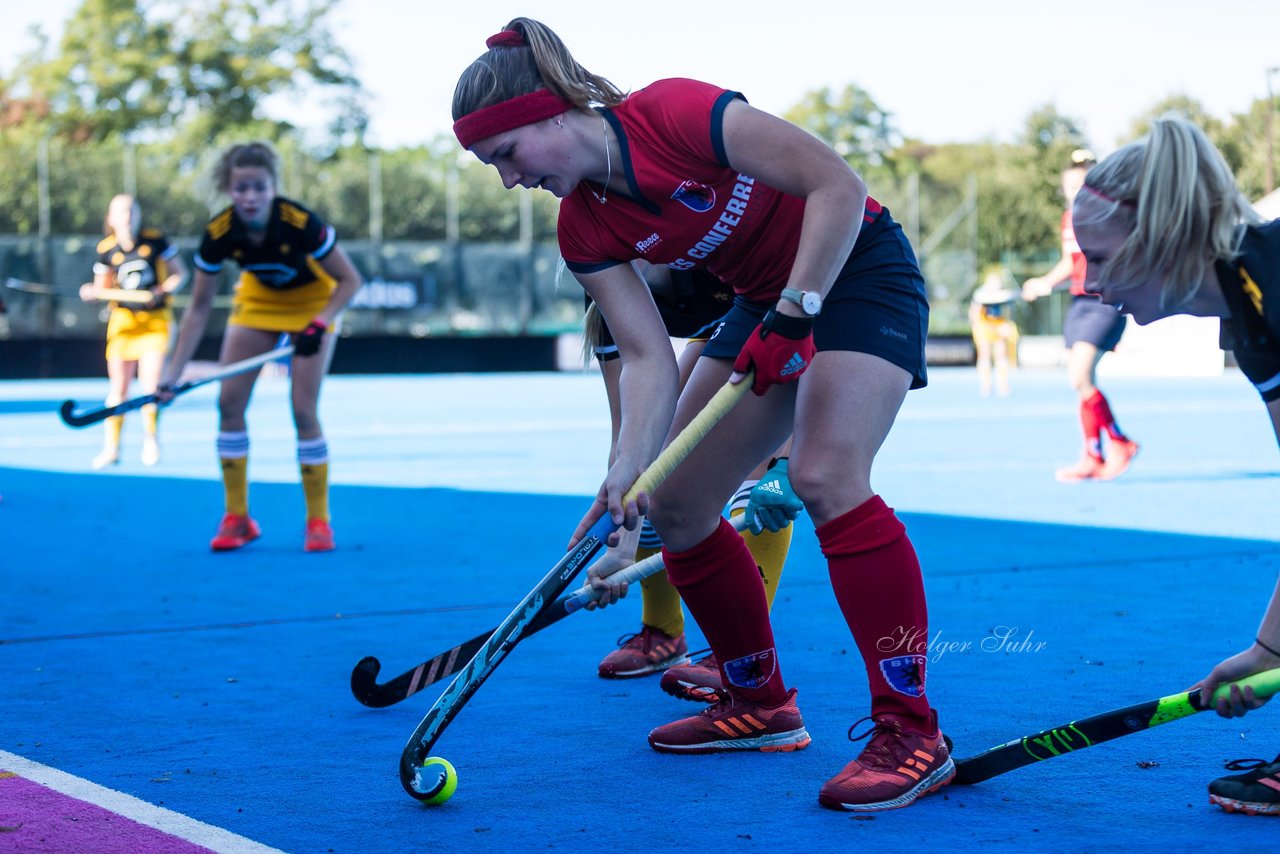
left=195, top=196, right=338, bottom=291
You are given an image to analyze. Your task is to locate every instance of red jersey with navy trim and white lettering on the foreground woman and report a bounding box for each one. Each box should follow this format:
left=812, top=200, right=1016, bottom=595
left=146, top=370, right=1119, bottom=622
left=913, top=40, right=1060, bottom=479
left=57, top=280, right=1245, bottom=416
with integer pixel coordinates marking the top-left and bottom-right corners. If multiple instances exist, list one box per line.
left=558, top=78, right=881, bottom=302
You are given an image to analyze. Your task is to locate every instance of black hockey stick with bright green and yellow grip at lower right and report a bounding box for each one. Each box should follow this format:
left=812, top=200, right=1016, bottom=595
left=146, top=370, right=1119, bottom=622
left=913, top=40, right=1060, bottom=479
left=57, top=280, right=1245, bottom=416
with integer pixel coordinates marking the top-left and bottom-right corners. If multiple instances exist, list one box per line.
left=952, top=668, right=1280, bottom=785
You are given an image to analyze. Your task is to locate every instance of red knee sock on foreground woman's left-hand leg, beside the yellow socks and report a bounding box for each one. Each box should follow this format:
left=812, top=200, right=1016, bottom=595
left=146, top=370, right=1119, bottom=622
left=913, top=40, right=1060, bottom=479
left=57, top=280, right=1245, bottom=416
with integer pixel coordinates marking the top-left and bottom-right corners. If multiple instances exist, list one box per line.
left=662, top=519, right=786, bottom=705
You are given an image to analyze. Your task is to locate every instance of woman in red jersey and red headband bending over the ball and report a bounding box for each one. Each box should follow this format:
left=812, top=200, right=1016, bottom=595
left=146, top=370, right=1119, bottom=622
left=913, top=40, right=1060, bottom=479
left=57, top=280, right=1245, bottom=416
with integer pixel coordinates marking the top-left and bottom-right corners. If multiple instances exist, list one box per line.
left=453, top=18, right=955, bottom=810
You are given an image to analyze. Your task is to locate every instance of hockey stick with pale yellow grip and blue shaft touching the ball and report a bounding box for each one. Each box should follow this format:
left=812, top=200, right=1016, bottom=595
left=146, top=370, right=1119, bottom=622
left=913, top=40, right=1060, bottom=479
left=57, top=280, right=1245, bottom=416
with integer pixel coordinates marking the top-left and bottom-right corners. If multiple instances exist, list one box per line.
left=399, top=373, right=754, bottom=802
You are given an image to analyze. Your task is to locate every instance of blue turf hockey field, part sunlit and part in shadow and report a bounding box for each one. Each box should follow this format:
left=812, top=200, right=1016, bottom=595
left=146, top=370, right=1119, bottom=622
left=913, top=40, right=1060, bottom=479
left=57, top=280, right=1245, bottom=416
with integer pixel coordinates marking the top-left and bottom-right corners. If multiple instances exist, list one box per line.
left=0, top=369, right=1280, bottom=851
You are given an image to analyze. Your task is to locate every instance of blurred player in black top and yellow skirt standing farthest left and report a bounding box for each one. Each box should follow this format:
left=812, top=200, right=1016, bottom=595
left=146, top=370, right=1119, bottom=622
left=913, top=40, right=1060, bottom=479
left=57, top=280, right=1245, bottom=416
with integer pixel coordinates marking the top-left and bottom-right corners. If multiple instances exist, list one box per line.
left=79, top=195, right=187, bottom=469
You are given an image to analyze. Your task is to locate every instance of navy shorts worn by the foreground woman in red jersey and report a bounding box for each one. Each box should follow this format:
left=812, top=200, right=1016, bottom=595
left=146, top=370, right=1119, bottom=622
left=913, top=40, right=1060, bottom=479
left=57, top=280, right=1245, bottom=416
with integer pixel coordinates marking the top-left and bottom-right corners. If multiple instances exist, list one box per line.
left=703, top=209, right=929, bottom=388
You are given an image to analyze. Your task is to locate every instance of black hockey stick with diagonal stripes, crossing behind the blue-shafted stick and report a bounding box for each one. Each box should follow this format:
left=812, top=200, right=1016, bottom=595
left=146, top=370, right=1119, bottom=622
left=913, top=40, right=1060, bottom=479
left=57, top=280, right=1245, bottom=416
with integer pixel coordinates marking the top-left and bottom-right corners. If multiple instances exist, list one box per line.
left=351, top=513, right=746, bottom=709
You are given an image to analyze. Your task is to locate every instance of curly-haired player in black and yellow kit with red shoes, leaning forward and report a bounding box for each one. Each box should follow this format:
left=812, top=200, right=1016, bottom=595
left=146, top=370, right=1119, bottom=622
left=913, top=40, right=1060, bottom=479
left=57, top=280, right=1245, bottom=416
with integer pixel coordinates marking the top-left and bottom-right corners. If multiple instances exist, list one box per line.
left=161, top=142, right=361, bottom=552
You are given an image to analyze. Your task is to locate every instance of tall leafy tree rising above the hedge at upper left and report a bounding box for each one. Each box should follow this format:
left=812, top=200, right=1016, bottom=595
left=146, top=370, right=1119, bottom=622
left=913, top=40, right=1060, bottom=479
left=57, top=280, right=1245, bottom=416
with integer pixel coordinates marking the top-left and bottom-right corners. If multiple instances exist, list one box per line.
left=0, top=0, right=367, bottom=141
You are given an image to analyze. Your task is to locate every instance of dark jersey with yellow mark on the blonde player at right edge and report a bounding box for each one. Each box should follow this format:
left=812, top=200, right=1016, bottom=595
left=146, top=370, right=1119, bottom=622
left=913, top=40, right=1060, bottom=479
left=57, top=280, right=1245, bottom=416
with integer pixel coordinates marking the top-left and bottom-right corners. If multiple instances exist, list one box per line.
left=1216, top=219, right=1280, bottom=403
